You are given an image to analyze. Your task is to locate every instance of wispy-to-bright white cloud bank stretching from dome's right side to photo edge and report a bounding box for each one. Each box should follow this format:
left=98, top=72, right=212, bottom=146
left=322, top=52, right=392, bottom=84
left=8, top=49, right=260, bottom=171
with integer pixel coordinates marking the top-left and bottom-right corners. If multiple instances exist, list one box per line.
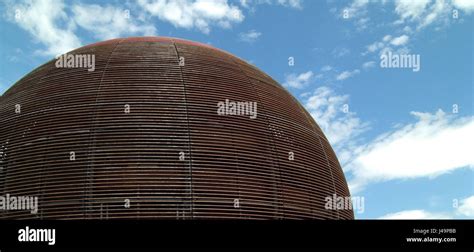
left=304, top=87, right=474, bottom=194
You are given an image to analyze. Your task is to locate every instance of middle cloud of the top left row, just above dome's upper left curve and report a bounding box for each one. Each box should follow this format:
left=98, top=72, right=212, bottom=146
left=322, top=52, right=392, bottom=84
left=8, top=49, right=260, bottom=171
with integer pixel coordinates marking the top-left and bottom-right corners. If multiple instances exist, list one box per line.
left=72, top=4, right=156, bottom=40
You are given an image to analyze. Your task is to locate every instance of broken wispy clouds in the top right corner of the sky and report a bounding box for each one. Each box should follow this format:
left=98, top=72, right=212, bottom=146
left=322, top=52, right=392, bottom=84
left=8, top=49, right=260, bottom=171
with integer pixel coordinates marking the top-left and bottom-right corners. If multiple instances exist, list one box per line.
left=333, top=0, right=474, bottom=58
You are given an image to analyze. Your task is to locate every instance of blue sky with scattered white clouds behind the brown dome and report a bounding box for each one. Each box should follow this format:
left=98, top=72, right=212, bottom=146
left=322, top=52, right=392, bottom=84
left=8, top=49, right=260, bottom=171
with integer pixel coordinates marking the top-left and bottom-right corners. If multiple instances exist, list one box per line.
left=0, top=0, right=474, bottom=219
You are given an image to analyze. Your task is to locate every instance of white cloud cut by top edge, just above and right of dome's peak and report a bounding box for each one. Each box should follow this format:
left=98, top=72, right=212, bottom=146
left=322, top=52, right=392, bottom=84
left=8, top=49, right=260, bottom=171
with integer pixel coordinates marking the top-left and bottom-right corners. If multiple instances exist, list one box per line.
left=138, top=0, right=244, bottom=33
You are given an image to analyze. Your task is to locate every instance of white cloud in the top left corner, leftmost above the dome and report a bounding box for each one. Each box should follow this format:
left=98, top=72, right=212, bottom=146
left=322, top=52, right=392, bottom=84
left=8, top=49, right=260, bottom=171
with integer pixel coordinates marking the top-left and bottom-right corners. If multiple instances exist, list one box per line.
left=7, top=0, right=81, bottom=56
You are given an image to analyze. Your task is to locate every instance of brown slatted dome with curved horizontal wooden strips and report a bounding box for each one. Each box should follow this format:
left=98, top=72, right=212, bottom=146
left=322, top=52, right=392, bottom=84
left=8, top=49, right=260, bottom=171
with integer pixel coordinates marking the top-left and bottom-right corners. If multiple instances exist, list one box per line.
left=0, top=37, right=353, bottom=219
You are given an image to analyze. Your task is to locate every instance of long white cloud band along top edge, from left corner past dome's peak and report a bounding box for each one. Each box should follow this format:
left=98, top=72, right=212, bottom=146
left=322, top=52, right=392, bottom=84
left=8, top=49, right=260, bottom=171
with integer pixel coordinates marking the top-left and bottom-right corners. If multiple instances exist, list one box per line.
left=6, top=0, right=248, bottom=56
